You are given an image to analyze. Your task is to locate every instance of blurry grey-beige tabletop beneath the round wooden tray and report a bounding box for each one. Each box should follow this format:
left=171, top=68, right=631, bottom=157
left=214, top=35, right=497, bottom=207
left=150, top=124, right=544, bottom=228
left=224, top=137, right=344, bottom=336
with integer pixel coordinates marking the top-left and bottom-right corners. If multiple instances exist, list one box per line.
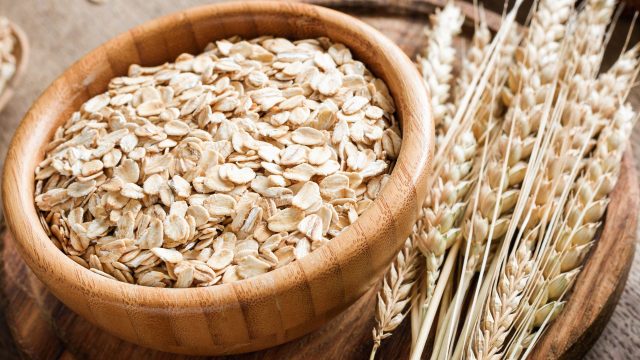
left=0, top=0, right=640, bottom=359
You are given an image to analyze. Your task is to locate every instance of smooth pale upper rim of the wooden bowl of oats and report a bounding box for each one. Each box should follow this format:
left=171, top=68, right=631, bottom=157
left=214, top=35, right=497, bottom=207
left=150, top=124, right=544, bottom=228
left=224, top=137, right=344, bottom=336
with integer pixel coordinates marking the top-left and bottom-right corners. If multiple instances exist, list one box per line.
left=2, top=1, right=434, bottom=308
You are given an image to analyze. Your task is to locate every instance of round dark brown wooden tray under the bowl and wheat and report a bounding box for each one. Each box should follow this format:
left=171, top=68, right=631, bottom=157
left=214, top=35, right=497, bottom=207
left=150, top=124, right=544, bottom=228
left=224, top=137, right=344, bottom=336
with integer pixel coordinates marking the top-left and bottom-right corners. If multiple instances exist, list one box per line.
left=0, top=0, right=639, bottom=359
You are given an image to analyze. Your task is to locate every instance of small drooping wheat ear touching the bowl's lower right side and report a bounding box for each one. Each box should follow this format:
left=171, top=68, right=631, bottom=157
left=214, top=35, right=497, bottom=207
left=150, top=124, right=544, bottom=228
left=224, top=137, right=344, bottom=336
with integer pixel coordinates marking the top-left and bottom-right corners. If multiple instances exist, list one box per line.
left=371, top=239, right=418, bottom=359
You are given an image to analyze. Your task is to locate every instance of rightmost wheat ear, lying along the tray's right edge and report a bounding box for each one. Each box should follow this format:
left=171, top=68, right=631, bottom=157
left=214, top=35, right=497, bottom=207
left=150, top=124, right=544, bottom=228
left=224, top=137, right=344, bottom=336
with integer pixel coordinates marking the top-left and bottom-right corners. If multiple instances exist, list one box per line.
left=512, top=46, right=639, bottom=352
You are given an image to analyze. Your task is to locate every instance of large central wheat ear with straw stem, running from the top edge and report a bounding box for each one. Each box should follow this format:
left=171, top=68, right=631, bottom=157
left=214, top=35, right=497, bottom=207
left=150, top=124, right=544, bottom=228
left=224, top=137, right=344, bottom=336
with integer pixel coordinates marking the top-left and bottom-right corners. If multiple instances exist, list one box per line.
left=424, top=0, right=573, bottom=357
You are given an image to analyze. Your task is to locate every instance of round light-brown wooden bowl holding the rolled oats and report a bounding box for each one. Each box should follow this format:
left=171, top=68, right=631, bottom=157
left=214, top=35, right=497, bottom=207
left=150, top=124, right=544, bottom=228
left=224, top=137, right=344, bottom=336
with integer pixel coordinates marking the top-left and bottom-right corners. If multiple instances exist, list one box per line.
left=3, top=2, right=434, bottom=355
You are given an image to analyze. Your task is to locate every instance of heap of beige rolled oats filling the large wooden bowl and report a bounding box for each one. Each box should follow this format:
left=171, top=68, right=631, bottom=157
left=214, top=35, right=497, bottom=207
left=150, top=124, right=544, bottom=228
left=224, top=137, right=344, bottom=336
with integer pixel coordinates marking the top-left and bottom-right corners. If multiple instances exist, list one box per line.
left=35, top=37, right=401, bottom=288
